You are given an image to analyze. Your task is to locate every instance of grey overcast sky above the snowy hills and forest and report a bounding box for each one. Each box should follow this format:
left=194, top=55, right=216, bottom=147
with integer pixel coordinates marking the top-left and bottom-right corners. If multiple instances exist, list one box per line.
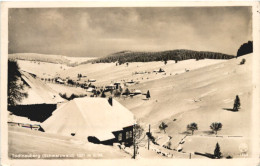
left=9, top=7, right=252, bottom=57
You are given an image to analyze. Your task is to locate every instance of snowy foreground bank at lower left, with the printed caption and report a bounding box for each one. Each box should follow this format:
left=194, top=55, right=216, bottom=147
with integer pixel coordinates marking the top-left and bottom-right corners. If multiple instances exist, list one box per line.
left=8, top=126, right=131, bottom=159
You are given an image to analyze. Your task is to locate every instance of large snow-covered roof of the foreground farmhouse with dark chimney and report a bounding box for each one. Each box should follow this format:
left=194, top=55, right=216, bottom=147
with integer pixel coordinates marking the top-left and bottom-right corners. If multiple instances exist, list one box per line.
left=41, top=97, right=135, bottom=141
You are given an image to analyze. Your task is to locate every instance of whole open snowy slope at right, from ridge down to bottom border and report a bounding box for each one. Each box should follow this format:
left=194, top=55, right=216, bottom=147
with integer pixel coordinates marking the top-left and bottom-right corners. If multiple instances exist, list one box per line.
left=117, top=55, right=252, bottom=157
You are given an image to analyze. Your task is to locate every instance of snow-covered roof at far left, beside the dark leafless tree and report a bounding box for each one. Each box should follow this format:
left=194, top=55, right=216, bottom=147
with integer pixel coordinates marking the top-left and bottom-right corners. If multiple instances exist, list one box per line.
left=19, top=71, right=64, bottom=105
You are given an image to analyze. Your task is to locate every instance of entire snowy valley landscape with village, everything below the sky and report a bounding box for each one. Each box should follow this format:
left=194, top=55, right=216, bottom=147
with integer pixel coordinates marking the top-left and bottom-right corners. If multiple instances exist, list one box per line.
left=7, top=7, right=253, bottom=160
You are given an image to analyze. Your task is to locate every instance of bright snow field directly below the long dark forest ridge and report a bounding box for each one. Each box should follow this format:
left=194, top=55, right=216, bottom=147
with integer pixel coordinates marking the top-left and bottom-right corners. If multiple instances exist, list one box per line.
left=59, top=59, right=226, bottom=86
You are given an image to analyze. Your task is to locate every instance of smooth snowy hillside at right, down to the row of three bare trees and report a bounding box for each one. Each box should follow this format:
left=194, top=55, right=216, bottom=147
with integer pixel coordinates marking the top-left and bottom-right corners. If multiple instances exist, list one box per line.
left=121, top=55, right=252, bottom=135
